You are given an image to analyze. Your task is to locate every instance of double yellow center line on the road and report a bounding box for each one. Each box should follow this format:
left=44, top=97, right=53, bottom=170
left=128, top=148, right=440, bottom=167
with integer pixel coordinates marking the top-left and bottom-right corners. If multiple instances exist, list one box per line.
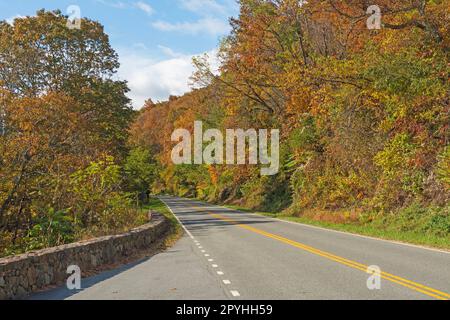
left=196, top=207, right=450, bottom=300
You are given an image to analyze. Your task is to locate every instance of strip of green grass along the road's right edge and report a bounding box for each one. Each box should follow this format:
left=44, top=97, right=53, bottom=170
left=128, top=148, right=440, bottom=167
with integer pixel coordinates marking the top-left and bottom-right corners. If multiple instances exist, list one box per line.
left=223, top=205, right=450, bottom=250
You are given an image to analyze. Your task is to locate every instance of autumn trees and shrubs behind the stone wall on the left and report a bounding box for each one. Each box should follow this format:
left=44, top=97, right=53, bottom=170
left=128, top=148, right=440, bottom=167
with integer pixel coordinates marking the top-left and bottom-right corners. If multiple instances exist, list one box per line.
left=0, top=11, right=145, bottom=256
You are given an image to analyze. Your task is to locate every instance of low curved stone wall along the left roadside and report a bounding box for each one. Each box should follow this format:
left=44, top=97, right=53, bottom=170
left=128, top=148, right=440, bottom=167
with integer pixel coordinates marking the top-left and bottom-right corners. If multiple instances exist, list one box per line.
left=0, top=214, right=170, bottom=300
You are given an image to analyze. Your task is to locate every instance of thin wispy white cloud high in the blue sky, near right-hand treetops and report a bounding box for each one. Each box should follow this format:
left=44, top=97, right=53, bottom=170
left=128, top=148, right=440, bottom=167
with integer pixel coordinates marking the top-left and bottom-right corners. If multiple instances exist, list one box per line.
left=152, top=17, right=230, bottom=36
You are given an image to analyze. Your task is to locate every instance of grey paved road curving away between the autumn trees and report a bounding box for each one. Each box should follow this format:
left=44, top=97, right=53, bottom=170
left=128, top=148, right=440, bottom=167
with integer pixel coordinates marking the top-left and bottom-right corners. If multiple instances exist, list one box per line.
left=32, top=197, right=450, bottom=299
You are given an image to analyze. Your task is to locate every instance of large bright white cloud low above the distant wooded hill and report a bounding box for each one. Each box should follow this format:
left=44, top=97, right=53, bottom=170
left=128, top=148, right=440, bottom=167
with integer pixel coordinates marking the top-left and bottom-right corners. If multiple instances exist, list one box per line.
left=118, top=46, right=218, bottom=109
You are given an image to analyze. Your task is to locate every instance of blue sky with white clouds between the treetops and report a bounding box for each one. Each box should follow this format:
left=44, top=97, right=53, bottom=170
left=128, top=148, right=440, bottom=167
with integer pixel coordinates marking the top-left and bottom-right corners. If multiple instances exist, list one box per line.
left=0, top=0, right=239, bottom=108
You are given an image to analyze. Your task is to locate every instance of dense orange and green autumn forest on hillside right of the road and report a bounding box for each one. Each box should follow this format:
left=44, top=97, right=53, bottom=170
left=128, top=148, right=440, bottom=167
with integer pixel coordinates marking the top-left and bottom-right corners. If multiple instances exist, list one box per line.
left=130, top=0, right=450, bottom=239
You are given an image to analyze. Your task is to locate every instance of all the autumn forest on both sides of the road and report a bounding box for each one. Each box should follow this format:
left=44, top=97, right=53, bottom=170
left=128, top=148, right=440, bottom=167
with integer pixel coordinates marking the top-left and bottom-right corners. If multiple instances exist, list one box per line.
left=0, top=0, right=450, bottom=256
